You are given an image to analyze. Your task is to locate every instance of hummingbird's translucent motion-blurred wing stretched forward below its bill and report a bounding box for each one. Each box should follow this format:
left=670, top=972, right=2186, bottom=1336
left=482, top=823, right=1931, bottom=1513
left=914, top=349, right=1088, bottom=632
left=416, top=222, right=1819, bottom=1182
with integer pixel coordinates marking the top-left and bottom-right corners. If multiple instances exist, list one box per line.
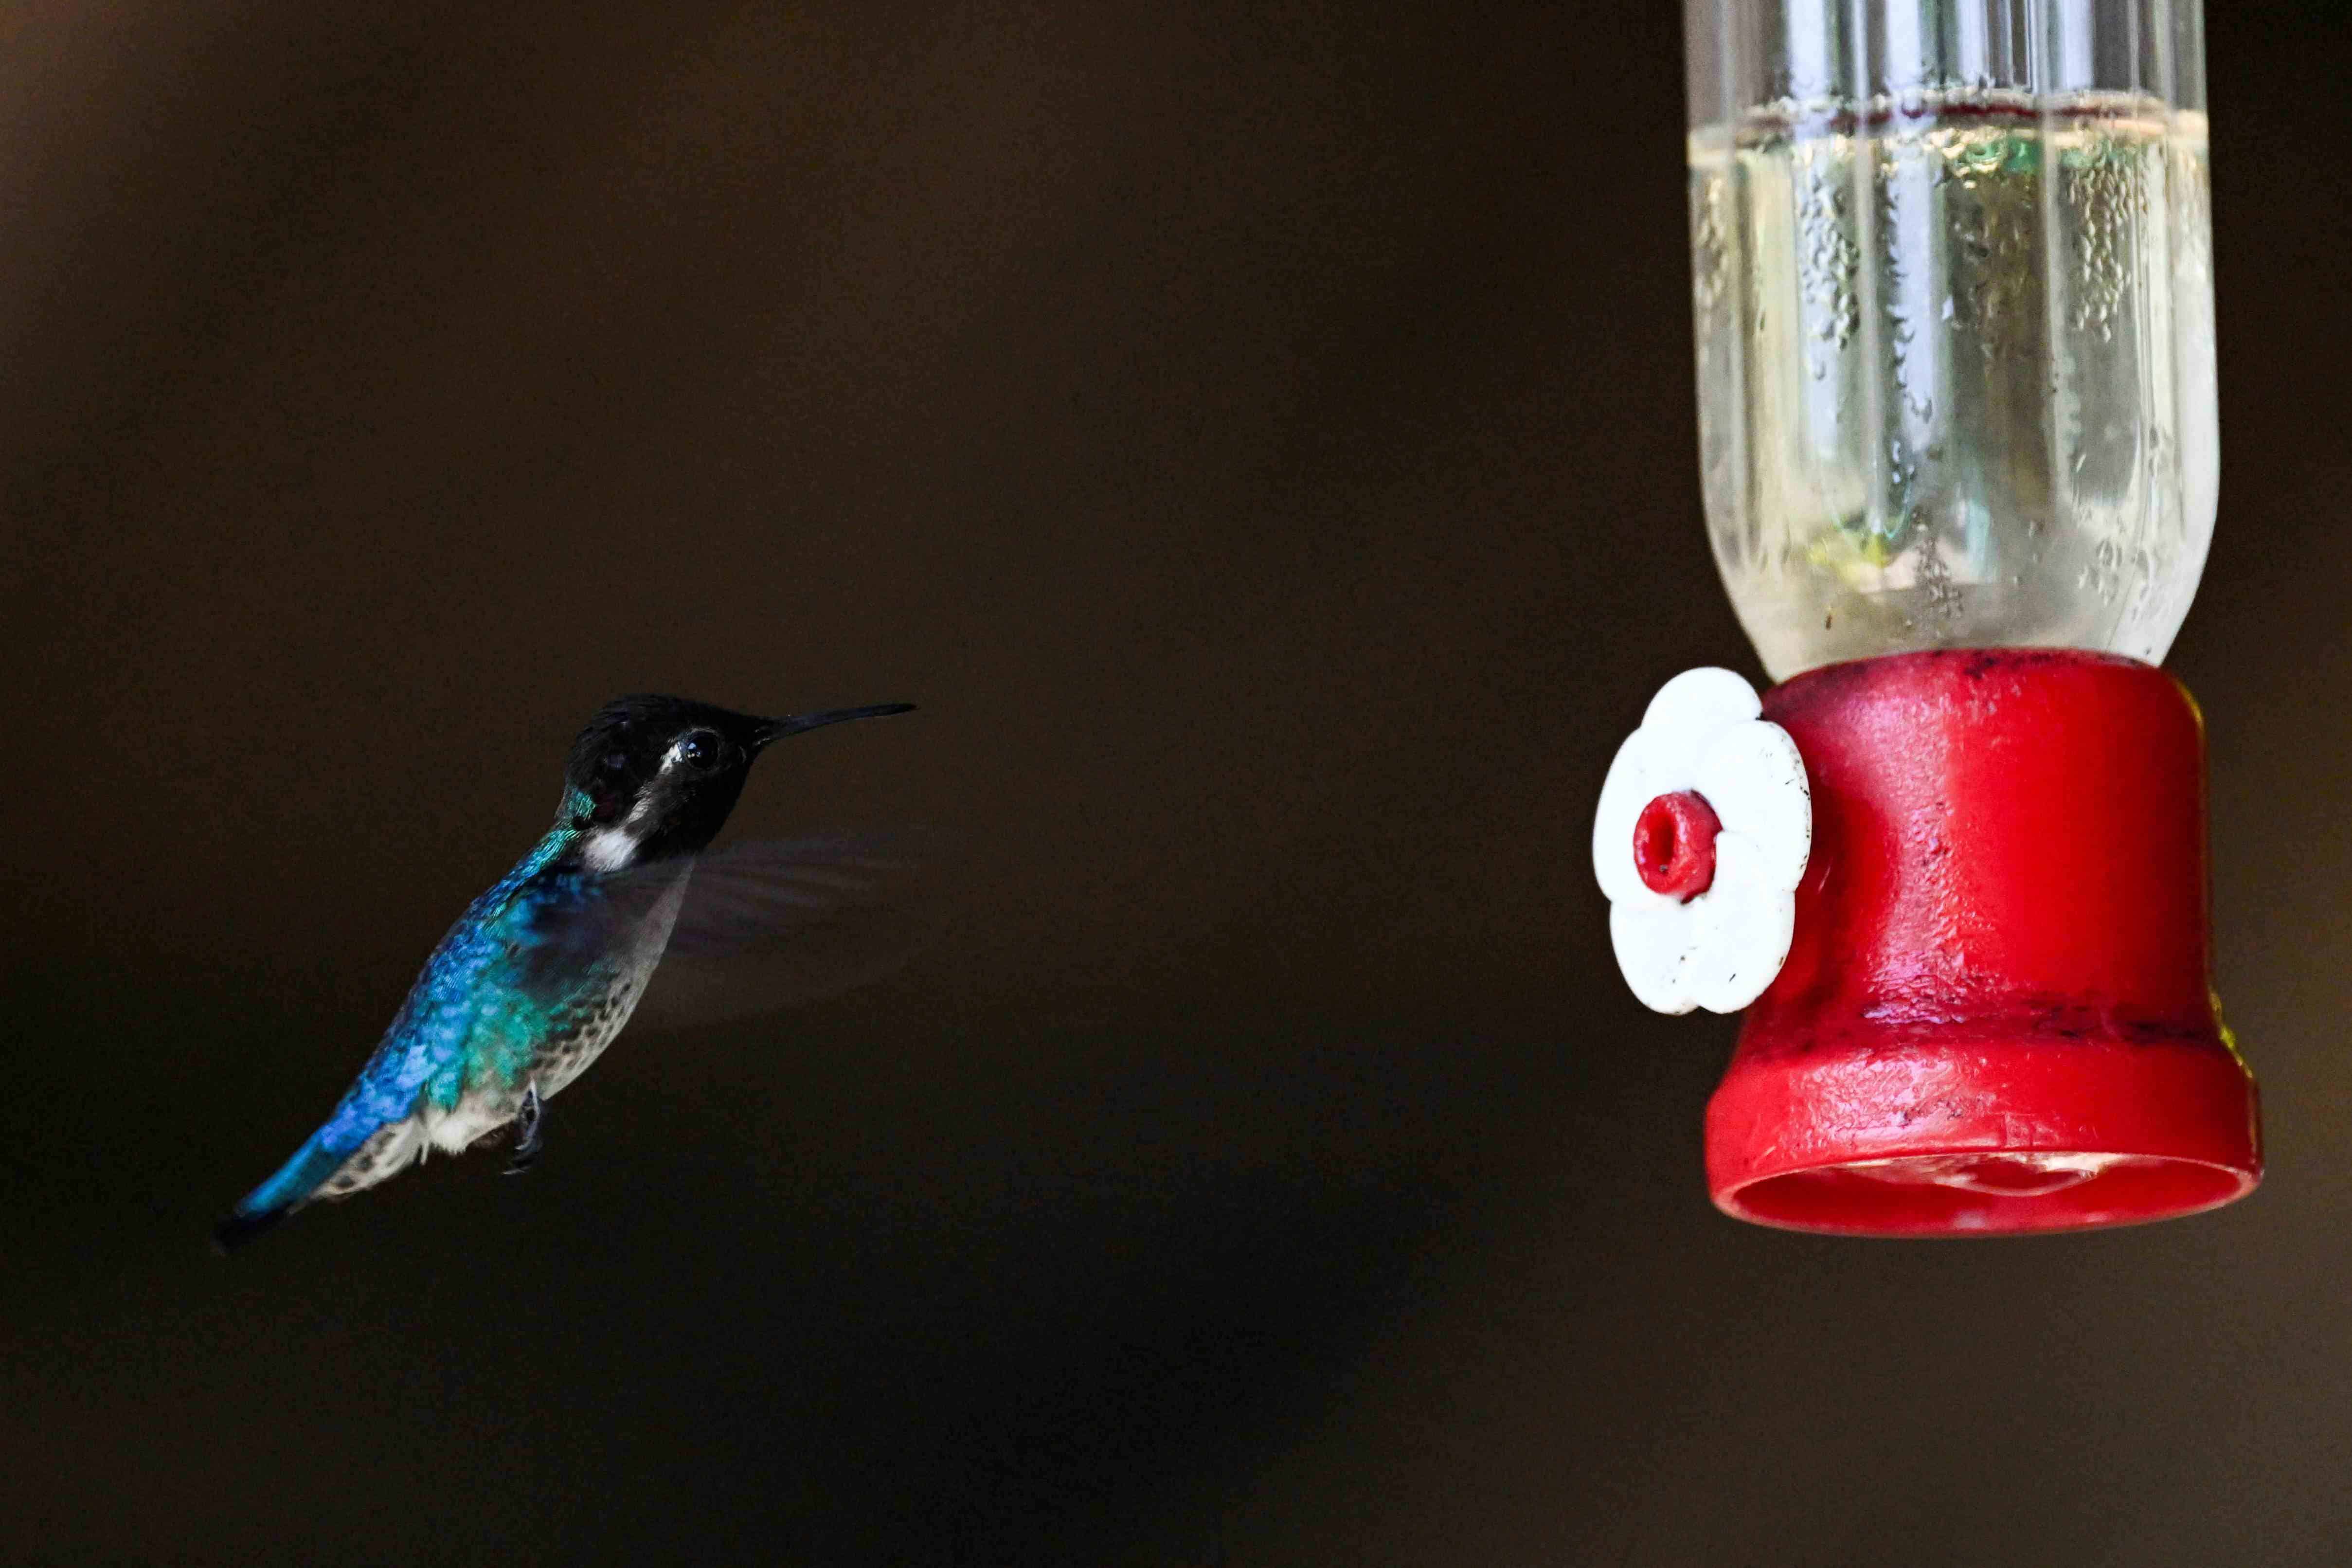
left=630, top=834, right=934, bottom=1029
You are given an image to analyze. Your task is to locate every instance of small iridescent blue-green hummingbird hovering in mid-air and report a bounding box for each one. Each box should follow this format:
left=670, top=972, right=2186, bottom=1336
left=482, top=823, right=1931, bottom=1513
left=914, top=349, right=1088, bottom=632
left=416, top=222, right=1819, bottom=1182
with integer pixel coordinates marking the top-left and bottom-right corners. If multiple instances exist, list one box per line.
left=214, top=696, right=913, bottom=1253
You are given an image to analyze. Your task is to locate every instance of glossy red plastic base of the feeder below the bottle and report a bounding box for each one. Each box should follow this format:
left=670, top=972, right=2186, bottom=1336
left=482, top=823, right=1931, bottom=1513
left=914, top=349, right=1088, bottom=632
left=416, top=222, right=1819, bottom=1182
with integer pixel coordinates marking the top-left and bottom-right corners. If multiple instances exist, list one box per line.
left=1707, top=649, right=2262, bottom=1237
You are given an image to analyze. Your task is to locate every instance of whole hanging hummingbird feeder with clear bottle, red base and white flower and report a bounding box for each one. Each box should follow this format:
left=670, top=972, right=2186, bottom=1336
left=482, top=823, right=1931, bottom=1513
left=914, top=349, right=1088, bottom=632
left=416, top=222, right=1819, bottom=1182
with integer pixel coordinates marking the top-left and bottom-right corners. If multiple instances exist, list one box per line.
left=1592, top=0, right=2262, bottom=1237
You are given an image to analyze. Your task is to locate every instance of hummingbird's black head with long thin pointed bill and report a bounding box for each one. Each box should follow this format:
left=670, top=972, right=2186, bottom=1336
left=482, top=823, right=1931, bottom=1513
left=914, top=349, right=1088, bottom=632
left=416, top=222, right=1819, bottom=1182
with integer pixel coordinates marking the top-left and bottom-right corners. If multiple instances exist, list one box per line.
left=562, top=696, right=913, bottom=872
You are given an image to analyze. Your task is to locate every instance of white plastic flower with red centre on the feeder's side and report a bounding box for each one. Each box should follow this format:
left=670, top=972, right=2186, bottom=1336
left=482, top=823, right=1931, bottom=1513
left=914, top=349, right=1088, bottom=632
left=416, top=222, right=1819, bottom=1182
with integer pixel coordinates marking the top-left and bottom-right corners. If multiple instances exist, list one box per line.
left=1592, top=670, right=1813, bottom=1013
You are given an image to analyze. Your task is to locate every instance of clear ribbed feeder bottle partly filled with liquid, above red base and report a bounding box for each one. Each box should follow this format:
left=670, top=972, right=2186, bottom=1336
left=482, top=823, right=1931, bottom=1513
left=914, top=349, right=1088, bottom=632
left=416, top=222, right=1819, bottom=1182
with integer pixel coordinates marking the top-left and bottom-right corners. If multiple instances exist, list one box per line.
left=1687, top=0, right=2220, bottom=679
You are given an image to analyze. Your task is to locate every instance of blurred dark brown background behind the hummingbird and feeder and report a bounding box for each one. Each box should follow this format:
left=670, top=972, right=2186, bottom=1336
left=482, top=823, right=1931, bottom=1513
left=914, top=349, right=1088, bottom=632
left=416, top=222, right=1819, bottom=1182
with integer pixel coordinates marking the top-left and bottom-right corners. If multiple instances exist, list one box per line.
left=0, top=0, right=2352, bottom=1566
